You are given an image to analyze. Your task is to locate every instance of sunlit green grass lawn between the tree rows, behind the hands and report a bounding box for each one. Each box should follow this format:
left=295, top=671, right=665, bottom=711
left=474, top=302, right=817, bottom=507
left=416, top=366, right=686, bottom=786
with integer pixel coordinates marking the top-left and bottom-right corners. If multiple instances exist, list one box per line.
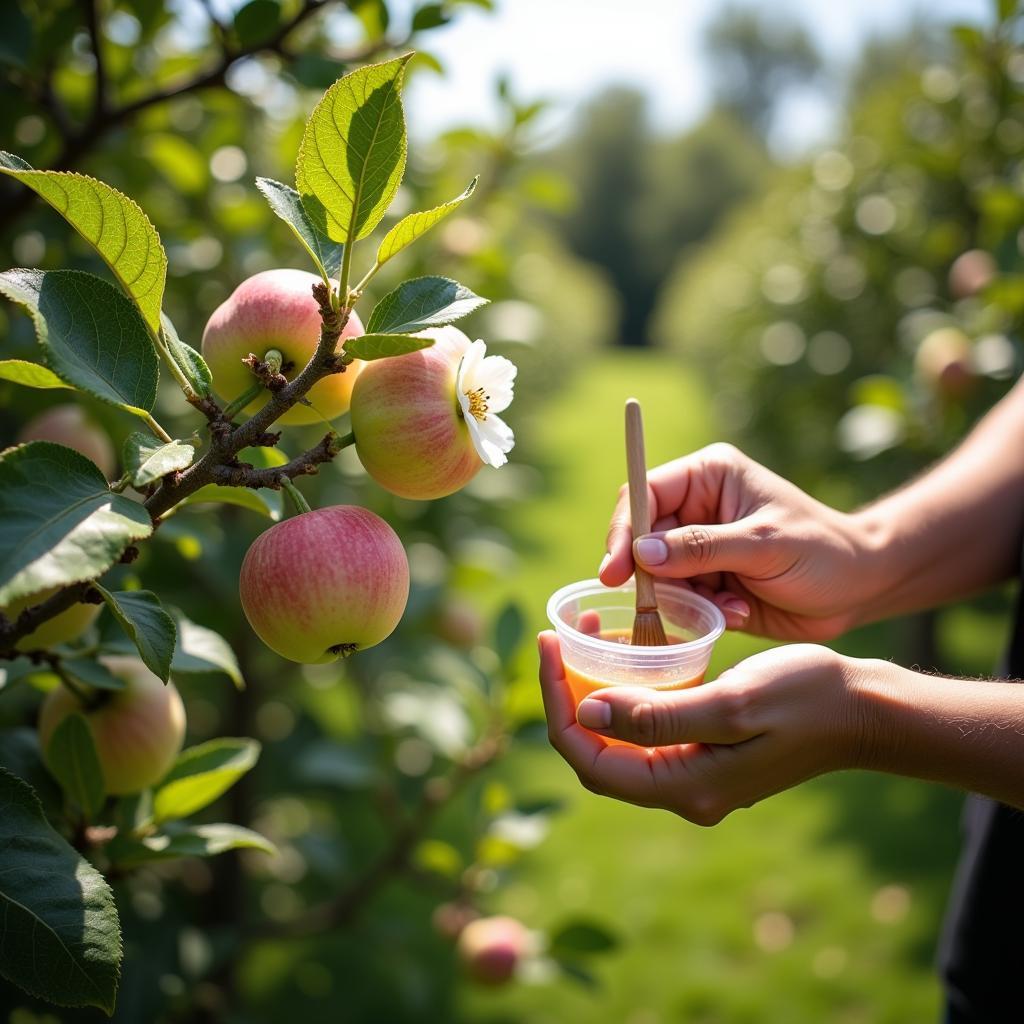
left=460, top=352, right=959, bottom=1024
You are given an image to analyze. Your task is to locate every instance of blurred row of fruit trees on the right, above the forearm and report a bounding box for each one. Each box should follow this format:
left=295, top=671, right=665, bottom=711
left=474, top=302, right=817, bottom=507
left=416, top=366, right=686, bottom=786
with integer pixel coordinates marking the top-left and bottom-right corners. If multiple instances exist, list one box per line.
left=653, top=2, right=1024, bottom=664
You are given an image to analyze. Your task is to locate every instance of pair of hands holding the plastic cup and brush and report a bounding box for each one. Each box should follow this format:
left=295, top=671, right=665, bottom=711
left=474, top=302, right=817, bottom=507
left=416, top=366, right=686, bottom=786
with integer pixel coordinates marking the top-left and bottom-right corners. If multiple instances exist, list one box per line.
left=540, top=444, right=874, bottom=824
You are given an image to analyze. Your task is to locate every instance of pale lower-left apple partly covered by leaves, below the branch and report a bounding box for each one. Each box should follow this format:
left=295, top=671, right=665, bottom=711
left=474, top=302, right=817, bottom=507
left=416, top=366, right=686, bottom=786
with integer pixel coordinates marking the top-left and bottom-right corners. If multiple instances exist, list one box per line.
left=39, top=655, right=185, bottom=796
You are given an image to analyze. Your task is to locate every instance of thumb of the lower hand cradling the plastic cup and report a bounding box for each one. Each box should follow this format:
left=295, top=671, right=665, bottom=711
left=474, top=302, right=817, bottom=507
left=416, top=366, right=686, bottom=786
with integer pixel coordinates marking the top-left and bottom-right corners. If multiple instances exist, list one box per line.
left=575, top=680, right=762, bottom=746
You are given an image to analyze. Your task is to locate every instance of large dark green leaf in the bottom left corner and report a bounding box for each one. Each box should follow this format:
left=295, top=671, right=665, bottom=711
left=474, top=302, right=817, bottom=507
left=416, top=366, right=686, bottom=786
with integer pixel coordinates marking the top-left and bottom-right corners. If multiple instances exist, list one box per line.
left=0, top=769, right=121, bottom=1016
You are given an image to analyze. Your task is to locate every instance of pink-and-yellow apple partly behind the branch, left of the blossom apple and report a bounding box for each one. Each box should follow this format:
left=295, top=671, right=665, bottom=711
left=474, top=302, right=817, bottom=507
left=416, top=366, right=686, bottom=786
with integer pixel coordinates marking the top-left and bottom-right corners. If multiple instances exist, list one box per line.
left=203, top=269, right=364, bottom=425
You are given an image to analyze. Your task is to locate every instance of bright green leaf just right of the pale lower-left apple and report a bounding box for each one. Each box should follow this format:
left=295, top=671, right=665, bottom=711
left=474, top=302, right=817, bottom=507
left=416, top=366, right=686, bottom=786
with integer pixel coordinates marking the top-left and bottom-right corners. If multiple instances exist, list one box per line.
left=153, top=738, right=260, bottom=823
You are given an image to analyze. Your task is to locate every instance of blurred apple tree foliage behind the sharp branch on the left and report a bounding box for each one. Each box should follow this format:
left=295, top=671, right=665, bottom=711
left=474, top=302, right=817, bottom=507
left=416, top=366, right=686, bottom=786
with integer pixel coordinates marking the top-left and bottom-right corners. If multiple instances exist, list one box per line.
left=0, top=0, right=614, bottom=1022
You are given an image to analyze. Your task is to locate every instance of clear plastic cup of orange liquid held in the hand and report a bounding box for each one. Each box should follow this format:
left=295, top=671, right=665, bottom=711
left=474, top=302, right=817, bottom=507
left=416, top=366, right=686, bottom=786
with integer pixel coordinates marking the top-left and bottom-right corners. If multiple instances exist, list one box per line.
left=548, top=580, right=725, bottom=741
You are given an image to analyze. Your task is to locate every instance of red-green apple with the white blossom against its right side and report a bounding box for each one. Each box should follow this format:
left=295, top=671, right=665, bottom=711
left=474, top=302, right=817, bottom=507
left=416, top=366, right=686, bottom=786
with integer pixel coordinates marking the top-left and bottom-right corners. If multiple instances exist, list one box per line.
left=351, top=331, right=483, bottom=501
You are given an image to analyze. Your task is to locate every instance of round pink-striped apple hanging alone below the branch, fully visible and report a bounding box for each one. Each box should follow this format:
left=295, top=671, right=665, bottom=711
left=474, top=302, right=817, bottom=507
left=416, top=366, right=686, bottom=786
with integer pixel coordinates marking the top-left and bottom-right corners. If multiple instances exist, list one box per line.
left=239, top=505, right=409, bottom=665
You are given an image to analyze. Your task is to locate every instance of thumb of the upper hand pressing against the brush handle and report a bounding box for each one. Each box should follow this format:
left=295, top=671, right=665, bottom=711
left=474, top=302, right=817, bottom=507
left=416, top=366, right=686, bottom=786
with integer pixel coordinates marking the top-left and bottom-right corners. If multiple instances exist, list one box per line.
left=633, top=520, right=768, bottom=580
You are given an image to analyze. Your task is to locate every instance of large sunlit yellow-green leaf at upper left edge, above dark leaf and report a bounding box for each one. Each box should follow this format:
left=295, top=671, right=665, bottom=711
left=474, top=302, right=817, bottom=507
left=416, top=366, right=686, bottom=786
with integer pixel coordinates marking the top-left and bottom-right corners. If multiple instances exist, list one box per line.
left=0, top=152, right=167, bottom=334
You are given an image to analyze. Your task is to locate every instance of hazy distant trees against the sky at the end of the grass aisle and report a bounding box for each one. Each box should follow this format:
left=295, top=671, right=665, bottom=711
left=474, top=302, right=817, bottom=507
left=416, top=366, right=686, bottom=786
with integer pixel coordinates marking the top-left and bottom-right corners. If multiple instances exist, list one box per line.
left=546, top=4, right=820, bottom=345
